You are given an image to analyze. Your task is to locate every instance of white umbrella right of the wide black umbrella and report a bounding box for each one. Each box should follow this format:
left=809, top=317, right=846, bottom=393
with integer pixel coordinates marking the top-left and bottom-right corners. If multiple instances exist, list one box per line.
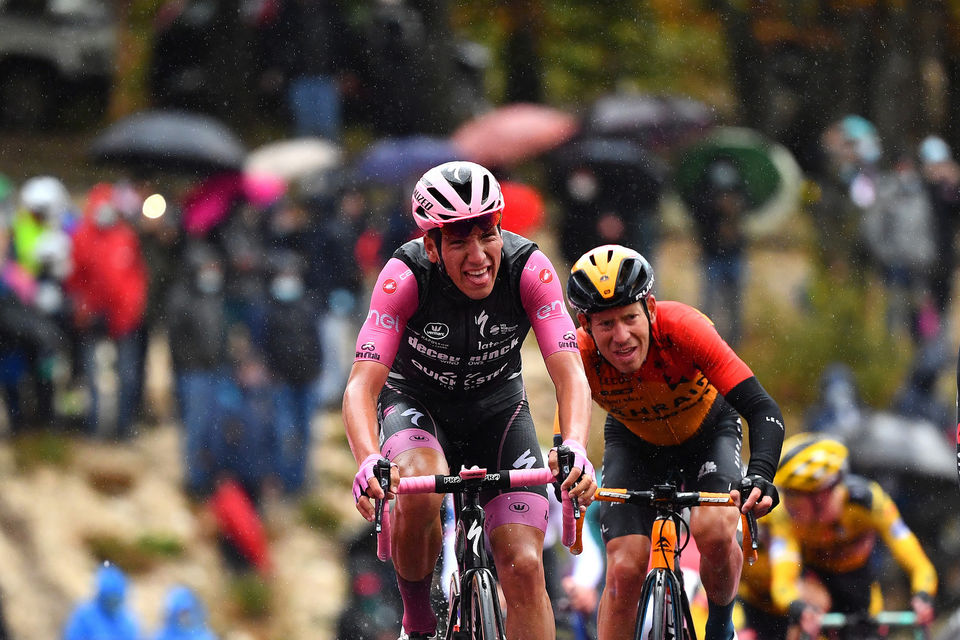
left=243, top=138, right=342, bottom=182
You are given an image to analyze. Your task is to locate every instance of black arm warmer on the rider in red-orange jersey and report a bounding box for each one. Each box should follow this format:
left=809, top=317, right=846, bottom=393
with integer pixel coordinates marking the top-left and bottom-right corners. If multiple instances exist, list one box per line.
left=725, top=376, right=783, bottom=482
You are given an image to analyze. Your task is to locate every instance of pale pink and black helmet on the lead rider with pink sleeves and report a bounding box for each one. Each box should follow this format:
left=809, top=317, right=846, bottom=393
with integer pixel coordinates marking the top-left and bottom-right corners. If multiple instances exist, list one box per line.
left=411, top=161, right=503, bottom=231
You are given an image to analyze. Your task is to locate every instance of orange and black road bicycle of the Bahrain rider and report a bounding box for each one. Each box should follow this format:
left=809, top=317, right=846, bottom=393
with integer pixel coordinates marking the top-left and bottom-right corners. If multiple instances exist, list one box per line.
left=595, top=483, right=757, bottom=640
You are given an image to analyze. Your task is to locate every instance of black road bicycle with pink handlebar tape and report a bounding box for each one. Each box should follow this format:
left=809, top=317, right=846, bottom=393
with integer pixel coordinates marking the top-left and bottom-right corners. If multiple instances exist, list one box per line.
left=374, top=447, right=583, bottom=640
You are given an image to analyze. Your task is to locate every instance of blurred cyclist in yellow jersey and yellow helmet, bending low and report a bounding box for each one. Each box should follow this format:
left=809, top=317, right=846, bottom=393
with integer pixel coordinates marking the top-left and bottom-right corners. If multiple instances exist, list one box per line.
left=769, top=433, right=937, bottom=624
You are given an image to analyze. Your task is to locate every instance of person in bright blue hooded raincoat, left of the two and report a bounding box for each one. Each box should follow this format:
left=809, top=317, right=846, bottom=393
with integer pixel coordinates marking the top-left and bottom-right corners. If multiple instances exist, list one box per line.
left=63, top=563, right=140, bottom=640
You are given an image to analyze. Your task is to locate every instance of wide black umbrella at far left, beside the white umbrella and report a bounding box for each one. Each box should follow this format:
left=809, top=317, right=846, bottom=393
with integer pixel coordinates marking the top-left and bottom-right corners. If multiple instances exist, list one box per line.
left=89, top=110, right=246, bottom=174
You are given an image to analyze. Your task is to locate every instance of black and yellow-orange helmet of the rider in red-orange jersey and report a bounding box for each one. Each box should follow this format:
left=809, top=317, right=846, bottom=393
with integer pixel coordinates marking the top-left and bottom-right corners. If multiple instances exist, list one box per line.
left=567, top=244, right=653, bottom=313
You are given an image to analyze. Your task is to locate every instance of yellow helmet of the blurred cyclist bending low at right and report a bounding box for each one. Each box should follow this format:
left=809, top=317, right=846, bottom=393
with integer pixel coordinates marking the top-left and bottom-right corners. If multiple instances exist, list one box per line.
left=773, top=433, right=850, bottom=493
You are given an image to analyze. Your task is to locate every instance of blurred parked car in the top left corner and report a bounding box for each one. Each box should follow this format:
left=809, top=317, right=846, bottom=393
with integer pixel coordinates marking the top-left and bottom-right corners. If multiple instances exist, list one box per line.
left=0, top=0, right=117, bottom=129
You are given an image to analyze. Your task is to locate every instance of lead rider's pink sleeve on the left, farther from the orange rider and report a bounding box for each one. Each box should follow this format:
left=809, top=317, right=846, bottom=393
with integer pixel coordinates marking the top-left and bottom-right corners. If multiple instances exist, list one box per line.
left=354, top=258, right=419, bottom=367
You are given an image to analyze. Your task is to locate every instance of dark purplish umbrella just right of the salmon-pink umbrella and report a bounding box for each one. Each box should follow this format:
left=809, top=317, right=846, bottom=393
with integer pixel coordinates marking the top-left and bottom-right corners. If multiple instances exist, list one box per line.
left=584, top=93, right=714, bottom=150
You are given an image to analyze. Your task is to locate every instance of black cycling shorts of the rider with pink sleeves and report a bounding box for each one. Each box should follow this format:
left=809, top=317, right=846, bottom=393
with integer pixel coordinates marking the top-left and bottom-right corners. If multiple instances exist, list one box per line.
left=377, top=383, right=547, bottom=504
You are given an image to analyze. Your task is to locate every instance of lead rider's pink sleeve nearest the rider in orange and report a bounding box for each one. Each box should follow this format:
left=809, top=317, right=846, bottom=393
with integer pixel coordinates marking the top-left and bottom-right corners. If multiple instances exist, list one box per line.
left=520, top=250, right=578, bottom=359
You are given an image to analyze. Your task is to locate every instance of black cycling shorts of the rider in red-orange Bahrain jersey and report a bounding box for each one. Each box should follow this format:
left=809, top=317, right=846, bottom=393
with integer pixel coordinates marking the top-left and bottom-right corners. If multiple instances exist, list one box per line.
left=600, top=405, right=743, bottom=543
